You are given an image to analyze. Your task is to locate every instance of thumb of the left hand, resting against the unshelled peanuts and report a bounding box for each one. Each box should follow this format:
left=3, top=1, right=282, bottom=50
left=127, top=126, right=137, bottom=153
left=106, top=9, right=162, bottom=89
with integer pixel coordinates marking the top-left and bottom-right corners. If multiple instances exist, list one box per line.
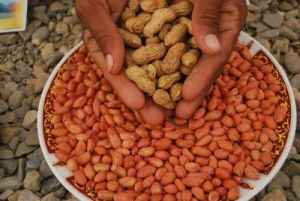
left=75, top=0, right=125, bottom=74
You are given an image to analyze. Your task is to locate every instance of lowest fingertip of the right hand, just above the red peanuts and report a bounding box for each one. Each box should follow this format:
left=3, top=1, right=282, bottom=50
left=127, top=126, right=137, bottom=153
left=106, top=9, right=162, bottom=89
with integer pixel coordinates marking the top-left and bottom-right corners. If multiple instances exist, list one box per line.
left=176, top=91, right=206, bottom=119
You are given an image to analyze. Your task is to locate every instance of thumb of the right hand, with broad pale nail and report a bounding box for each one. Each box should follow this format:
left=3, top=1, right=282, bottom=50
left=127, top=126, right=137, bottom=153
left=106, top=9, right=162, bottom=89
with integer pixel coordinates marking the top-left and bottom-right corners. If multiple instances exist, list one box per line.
left=192, top=0, right=223, bottom=54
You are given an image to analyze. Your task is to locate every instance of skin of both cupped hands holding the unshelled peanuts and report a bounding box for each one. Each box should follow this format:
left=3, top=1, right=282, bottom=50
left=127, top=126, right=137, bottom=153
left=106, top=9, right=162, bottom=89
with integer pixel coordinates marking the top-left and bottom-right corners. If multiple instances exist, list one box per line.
left=75, top=0, right=247, bottom=124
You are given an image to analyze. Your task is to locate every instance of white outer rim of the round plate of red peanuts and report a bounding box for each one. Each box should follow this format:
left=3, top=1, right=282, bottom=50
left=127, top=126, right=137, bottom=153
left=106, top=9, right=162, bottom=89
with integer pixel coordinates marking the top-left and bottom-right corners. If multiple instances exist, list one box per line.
left=37, top=31, right=297, bottom=201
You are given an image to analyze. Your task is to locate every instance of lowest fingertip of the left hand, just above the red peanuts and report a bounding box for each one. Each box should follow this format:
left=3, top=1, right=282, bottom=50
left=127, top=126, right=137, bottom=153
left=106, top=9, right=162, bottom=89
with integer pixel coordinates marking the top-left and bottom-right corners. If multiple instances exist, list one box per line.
left=139, top=98, right=165, bottom=125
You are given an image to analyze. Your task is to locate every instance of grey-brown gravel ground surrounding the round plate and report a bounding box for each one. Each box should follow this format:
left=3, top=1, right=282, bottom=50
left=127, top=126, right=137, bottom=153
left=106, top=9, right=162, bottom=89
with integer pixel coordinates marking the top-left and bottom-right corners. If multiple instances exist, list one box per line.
left=0, top=0, right=300, bottom=201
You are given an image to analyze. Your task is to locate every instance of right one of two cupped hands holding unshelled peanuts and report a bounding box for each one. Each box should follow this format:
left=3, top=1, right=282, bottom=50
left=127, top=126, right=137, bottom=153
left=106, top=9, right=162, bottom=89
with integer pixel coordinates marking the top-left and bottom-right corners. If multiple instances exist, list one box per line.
left=176, top=0, right=247, bottom=119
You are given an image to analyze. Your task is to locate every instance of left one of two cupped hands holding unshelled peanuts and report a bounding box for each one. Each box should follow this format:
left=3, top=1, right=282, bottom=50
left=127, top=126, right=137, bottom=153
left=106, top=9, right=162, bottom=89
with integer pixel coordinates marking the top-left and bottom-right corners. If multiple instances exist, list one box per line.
left=75, top=0, right=164, bottom=124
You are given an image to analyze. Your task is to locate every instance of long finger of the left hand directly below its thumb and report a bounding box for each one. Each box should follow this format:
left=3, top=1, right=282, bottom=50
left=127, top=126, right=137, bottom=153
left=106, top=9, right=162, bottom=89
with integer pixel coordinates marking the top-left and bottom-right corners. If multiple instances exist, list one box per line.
left=83, top=31, right=145, bottom=110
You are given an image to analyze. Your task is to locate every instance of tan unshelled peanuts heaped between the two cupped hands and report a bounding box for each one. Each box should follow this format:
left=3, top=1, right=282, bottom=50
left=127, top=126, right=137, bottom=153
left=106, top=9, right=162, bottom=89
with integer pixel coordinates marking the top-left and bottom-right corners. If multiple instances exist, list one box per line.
left=119, top=0, right=200, bottom=109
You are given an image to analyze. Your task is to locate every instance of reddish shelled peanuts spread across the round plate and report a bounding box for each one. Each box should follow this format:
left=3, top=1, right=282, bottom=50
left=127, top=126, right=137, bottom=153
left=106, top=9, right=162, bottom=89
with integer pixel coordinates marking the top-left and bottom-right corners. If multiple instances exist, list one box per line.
left=51, top=38, right=287, bottom=201
